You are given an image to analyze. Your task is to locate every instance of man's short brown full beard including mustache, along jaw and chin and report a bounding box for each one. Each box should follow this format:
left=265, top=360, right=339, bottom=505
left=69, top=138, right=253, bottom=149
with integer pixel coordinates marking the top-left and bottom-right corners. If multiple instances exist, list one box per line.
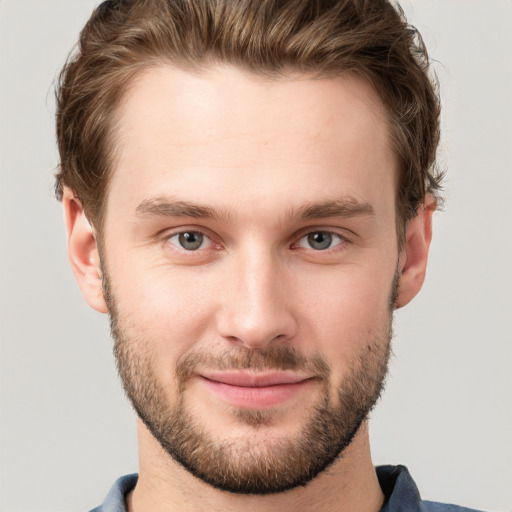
left=103, top=273, right=398, bottom=494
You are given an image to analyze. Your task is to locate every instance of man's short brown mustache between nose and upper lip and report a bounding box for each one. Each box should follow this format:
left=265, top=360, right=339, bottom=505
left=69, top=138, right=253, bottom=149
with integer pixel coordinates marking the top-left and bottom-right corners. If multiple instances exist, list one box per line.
left=175, top=345, right=331, bottom=383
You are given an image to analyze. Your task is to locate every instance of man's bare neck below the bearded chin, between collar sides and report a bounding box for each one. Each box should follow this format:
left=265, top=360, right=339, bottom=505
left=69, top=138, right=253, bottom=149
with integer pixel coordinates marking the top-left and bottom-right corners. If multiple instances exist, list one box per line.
left=127, top=421, right=384, bottom=512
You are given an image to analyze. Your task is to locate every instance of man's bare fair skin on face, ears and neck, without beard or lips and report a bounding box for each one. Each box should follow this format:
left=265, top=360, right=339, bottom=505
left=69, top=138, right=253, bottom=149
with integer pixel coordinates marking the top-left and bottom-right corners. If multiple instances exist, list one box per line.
left=63, top=66, right=435, bottom=512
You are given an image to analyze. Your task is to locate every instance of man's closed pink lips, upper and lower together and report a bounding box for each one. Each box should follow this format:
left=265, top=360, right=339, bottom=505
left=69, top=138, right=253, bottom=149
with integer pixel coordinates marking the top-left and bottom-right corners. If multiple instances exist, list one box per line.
left=200, top=371, right=313, bottom=409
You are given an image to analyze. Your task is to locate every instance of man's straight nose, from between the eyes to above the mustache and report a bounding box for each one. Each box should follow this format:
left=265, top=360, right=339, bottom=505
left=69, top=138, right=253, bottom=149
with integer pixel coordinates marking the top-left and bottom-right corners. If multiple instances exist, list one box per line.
left=217, top=247, right=297, bottom=349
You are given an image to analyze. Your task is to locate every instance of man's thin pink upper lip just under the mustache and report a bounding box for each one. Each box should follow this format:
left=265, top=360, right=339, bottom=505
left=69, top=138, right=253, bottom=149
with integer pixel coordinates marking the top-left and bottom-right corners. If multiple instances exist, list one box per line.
left=201, top=371, right=311, bottom=388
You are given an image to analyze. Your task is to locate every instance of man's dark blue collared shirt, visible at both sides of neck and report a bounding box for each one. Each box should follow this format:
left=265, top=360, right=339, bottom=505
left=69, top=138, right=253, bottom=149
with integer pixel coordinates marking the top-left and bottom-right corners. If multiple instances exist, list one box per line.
left=91, top=466, right=484, bottom=512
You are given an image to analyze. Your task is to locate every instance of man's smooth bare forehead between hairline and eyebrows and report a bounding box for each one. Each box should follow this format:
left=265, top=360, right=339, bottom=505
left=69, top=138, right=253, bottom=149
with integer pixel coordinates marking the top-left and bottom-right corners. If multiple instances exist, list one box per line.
left=107, top=65, right=396, bottom=223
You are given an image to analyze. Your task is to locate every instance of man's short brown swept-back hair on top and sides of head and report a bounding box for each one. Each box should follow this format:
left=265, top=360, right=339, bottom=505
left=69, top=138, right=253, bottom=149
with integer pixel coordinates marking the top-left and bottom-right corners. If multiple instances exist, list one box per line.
left=55, top=0, right=442, bottom=233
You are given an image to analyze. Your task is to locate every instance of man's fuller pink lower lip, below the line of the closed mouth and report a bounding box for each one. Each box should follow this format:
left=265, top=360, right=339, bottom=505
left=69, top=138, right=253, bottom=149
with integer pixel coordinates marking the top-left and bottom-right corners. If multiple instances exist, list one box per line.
left=202, top=377, right=311, bottom=409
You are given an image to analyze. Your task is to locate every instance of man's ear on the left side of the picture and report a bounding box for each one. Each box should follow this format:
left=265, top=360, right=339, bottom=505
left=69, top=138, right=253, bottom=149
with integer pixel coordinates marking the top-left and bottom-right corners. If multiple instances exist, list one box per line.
left=62, top=187, right=108, bottom=313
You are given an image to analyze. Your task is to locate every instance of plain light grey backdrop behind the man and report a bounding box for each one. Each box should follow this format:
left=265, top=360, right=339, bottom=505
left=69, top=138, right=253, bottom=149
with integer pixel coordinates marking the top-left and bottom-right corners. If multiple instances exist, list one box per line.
left=0, top=0, right=512, bottom=512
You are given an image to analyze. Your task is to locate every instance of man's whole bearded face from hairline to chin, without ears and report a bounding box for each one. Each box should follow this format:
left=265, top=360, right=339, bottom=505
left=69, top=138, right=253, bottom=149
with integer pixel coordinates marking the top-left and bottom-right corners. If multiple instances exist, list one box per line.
left=97, top=67, right=399, bottom=493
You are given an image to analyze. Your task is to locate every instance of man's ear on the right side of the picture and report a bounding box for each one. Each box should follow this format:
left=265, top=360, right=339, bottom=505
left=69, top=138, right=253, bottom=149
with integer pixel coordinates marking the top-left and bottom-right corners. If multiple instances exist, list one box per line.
left=395, top=194, right=437, bottom=309
